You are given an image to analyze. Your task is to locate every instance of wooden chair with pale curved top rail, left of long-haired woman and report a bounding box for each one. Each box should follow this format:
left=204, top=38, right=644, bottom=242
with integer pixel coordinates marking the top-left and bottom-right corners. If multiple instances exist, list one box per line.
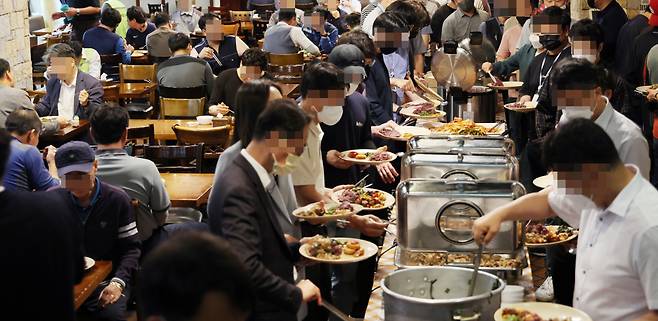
left=171, top=124, right=231, bottom=159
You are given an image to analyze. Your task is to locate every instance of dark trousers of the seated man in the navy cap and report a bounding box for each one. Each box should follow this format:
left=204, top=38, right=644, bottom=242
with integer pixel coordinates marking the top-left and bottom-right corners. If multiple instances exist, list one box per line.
left=78, top=281, right=130, bottom=321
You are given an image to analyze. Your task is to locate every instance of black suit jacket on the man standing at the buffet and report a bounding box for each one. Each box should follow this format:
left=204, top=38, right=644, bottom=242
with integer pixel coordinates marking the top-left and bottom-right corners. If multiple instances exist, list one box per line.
left=208, top=155, right=302, bottom=321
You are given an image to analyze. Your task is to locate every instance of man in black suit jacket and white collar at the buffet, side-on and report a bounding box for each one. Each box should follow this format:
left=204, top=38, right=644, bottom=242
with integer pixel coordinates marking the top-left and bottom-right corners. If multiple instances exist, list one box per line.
left=208, top=99, right=321, bottom=321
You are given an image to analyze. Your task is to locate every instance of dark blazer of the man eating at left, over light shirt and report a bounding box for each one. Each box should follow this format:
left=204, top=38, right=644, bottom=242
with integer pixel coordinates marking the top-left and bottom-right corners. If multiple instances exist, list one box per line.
left=36, top=70, right=103, bottom=119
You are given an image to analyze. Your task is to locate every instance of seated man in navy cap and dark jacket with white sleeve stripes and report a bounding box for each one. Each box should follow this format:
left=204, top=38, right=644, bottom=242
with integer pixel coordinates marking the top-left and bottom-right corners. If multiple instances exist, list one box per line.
left=55, top=141, right=141, bottom=320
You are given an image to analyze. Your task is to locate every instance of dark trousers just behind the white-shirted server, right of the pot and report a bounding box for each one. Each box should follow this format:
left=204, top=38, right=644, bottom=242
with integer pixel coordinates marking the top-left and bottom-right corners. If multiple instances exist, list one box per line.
left=546, top=245, right=576, bottom=306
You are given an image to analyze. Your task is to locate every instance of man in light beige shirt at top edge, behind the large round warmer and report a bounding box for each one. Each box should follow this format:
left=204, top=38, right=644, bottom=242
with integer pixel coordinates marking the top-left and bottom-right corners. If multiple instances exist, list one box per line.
left=441, top=0, right=489, bottom=42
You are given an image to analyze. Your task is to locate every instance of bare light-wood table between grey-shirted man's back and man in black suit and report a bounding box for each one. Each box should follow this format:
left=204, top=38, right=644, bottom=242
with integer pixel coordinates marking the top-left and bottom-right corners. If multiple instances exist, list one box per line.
left=160, top=173, right=214, bottom=208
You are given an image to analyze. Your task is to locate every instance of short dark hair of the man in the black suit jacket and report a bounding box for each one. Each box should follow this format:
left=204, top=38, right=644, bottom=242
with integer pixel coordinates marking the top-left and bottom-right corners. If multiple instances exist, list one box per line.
left=252, top=99, right=311, bottom=140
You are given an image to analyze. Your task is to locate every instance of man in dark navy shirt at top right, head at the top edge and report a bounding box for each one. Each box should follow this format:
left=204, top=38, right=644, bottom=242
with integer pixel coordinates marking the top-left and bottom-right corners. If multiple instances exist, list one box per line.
left=587, top=0, right=628, bottom=65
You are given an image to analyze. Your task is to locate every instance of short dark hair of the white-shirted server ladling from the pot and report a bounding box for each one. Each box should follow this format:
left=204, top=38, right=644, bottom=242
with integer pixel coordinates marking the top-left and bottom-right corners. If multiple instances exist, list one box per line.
left=542, top=118, right=622, bottom=171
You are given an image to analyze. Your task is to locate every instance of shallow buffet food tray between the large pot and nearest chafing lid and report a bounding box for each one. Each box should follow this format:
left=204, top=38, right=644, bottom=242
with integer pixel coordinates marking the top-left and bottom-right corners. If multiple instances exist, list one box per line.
left=394, top=246, right=528, bottom=280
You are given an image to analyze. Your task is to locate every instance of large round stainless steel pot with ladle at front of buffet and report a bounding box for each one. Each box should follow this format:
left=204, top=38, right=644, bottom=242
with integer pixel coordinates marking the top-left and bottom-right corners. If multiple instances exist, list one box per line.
left=381, top=266, right=505, bottom=321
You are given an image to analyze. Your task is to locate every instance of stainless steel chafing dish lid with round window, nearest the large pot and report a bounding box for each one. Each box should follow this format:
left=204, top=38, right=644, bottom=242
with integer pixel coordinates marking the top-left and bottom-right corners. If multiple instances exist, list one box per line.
left=397, top=178, right=525, bottom=253
